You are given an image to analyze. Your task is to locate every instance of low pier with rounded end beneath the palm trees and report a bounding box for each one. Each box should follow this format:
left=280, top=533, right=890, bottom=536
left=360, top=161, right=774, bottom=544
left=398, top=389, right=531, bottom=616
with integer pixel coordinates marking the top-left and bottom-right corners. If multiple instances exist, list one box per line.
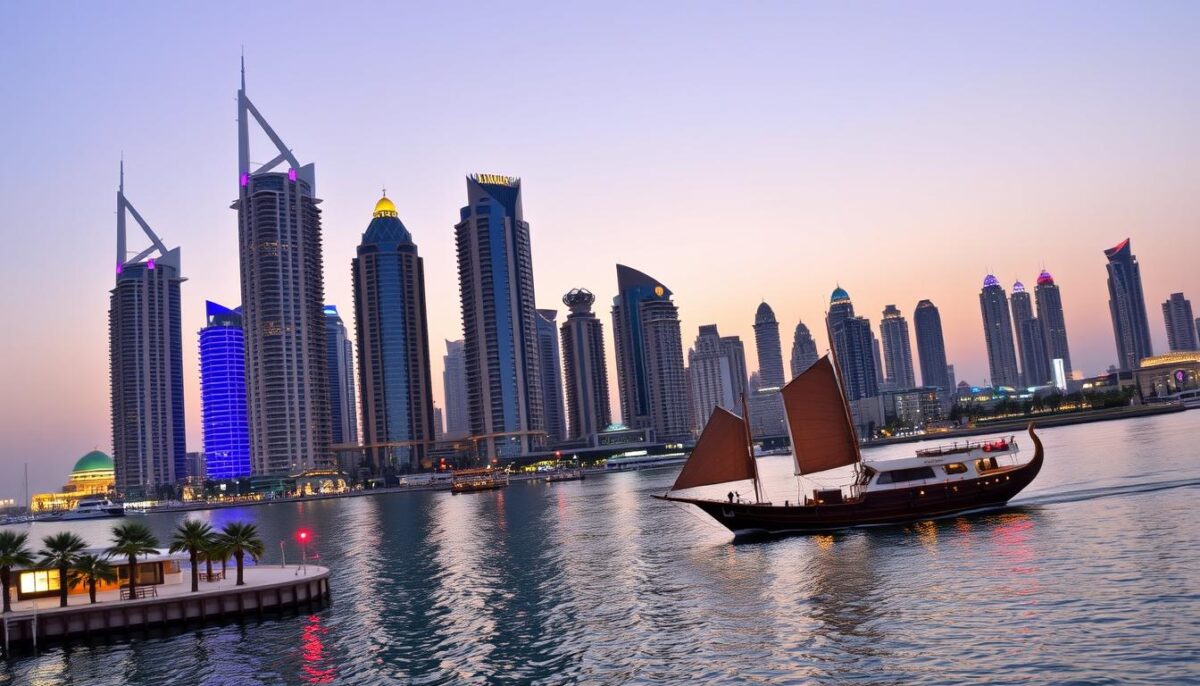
left=0, top=565, right=330, bottom=655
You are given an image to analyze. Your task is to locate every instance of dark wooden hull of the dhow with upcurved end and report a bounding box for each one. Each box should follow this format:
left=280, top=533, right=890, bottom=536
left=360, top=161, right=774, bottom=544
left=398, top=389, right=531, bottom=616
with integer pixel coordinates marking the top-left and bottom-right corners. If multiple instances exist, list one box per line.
left=656, top=429, right=1044, bottom=535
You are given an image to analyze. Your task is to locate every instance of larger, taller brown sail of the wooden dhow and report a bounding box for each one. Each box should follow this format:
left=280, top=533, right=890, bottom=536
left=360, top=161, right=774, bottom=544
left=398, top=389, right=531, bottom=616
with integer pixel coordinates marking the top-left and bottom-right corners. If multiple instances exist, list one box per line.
left=780, top=355, right=859, bottom=474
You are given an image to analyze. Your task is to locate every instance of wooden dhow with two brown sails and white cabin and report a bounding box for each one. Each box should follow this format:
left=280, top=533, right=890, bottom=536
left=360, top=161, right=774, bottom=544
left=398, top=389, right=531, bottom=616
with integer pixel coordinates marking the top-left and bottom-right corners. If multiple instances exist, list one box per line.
left=655, top=355, right=1044, bottom=535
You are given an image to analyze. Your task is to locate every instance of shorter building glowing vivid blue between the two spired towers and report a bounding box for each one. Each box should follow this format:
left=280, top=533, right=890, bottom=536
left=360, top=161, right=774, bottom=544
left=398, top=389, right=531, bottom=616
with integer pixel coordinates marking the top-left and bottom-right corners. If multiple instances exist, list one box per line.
left=200, top=301, right=250, bottom=480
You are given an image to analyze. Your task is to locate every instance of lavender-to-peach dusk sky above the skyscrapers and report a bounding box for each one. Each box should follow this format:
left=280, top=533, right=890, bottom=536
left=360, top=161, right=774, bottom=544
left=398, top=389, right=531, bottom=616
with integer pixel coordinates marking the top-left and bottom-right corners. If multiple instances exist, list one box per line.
left=0, top=2, right=1200, bottom=499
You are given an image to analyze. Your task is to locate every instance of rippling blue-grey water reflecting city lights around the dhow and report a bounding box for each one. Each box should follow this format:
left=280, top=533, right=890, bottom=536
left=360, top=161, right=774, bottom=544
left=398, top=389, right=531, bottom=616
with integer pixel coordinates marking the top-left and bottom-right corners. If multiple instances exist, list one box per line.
left=0, top=411, right=1200, bottom=686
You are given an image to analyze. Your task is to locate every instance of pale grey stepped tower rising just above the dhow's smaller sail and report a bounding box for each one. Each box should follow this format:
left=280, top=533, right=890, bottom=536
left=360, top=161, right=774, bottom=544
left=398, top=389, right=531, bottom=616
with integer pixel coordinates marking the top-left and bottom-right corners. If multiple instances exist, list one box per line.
left=688, top=324, right=746, bottom=432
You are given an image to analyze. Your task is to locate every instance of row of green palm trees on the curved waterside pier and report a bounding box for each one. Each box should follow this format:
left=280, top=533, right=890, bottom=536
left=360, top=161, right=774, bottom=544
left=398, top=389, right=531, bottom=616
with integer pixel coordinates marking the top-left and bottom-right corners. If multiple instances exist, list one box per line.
left=0, top=519, right=265, bottom=612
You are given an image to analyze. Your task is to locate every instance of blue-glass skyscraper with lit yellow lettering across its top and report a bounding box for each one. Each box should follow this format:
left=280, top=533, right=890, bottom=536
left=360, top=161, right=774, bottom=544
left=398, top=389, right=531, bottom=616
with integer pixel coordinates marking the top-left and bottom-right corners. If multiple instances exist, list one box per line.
left=455, top=174, right=546, bottom=461
